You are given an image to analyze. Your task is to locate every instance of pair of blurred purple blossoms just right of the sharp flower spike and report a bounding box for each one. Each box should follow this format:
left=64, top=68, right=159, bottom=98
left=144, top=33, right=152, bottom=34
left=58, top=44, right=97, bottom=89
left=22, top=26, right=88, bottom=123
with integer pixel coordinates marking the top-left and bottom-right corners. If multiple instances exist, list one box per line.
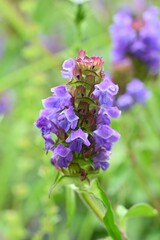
left=116, top=79, right=150, bottom=111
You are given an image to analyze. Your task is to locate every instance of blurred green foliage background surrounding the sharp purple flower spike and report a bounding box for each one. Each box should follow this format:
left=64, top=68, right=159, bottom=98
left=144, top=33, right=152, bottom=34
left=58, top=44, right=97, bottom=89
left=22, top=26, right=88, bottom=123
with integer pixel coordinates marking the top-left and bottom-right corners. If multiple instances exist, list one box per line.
left=0, top=0, right=160, bottom=240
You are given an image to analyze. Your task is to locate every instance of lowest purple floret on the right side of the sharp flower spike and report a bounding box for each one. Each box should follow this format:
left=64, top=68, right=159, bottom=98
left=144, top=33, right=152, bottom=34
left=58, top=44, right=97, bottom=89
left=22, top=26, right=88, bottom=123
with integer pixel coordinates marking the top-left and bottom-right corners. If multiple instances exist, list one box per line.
left=93, top=149, right=111, bottom=171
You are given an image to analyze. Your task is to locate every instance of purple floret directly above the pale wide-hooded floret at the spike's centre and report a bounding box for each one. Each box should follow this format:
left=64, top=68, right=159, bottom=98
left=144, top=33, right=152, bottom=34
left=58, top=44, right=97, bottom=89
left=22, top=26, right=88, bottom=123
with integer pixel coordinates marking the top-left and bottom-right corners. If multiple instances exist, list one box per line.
left=58, top=107, right=79, bottom=132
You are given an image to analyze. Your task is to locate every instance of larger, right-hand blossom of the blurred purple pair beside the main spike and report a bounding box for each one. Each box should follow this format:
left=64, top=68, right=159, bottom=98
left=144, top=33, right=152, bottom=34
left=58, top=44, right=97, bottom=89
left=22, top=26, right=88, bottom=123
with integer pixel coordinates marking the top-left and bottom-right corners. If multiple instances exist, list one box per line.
left=126, top=79, right=150, bottom=104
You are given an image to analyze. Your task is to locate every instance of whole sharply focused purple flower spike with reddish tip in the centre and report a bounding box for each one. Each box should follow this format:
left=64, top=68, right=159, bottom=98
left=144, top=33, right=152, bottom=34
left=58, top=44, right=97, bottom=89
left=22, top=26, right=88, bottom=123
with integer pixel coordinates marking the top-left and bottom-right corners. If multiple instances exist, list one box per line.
left=35, top=50, right=120, bottom=177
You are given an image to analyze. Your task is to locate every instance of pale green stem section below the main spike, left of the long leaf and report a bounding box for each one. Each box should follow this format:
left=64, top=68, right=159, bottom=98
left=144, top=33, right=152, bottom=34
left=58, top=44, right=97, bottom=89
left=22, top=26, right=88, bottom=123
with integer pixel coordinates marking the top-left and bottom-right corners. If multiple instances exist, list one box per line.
left=79, top=192, right=104, bottom=224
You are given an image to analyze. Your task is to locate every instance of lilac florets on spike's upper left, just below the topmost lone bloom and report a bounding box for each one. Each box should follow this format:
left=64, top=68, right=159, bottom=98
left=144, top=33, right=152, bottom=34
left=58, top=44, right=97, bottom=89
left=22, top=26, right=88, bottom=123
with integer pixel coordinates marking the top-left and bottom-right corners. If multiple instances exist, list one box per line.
left=42, top=85, right=71, bottom=110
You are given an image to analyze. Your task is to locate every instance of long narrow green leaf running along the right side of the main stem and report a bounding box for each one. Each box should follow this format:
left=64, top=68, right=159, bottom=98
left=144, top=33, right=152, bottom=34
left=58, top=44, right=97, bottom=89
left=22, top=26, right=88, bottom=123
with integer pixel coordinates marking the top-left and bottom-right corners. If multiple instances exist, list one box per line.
left=92, top=181, right=122, bottom=240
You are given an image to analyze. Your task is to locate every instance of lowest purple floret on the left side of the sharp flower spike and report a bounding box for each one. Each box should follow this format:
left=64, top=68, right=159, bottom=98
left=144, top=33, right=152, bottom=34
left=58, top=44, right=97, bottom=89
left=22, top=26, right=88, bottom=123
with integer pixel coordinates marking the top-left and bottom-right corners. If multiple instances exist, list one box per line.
left=51, top=143, right=72, bottom=168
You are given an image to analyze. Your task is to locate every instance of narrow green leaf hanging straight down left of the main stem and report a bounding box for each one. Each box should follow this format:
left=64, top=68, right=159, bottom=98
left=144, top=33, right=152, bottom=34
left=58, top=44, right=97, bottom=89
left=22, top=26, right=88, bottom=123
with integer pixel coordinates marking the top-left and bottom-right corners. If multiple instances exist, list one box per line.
left=66, top=186, right=76, bottom=227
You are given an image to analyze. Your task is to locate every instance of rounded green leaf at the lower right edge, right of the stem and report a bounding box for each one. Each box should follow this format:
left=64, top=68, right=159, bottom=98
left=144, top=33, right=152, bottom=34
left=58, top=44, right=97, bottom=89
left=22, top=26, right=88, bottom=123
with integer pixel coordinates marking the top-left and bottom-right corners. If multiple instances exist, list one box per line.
left=124, top=203, right=158, bottom=218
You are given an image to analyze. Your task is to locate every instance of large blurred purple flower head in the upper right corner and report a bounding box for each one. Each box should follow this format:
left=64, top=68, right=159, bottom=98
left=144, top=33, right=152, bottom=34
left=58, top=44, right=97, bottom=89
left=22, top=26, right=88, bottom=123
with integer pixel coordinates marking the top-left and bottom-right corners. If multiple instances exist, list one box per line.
left=110, top=7, right=160, bottom=75
